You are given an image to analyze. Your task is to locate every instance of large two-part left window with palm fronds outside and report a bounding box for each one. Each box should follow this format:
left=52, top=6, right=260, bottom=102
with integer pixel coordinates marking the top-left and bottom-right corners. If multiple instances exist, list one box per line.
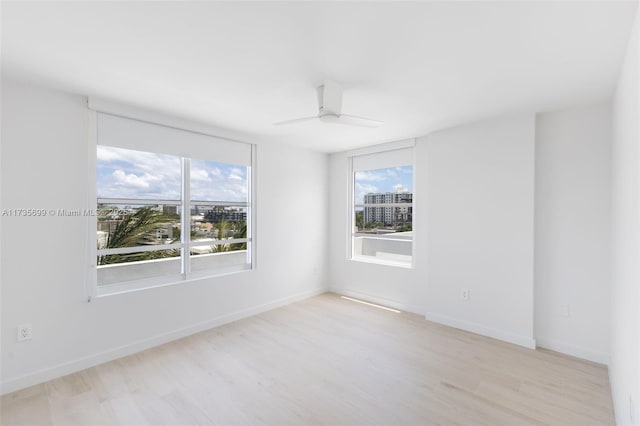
left=92, top=113, right=253, bottom=294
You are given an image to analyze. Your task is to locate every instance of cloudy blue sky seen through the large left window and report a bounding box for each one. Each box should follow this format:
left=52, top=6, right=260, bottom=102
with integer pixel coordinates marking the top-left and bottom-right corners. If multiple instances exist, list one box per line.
left=97, top=145, right=248, bottom=201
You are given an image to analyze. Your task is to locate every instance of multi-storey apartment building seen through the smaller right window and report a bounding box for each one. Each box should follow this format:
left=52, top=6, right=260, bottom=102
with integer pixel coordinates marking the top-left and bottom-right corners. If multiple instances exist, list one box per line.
left=364, top=189, right=413, bottom=226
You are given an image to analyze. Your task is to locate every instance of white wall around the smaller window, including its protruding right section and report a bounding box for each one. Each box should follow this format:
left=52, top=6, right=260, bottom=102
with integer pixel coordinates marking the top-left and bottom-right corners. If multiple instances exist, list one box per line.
left=330, top=115, right=534, bottom=346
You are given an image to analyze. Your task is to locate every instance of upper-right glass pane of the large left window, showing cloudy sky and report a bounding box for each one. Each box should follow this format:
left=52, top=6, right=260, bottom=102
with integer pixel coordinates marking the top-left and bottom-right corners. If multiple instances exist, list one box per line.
left=191, top=160, right=249, bottom=202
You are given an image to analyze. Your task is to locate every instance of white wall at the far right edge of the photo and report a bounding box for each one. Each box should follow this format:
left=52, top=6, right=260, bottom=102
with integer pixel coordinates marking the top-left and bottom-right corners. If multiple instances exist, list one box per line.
left=609, top=8, right=640, bottom=425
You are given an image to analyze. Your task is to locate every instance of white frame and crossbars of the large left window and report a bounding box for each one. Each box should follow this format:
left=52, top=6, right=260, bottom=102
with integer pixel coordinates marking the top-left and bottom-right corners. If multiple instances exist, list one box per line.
left=86, top=108, right=257, bottom=301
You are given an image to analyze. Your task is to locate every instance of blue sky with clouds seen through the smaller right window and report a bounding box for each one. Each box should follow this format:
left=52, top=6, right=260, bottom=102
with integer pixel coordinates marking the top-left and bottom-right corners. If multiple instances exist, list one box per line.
left=354, top=166, right=413, bottom=204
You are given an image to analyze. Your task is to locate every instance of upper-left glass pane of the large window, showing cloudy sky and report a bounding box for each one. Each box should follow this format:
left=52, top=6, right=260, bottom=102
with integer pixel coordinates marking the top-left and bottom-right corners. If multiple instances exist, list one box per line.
left=97, top=145, right=181, bottom=200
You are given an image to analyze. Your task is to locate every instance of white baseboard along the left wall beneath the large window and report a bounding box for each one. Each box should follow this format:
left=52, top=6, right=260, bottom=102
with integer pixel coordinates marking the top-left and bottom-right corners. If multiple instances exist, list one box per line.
left=0, top=288, right=327, bottom=395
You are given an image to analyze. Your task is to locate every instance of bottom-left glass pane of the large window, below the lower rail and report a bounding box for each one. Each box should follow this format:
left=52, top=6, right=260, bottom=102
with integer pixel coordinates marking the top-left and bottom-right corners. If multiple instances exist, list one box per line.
left=98, top=249, right=181, bottom=285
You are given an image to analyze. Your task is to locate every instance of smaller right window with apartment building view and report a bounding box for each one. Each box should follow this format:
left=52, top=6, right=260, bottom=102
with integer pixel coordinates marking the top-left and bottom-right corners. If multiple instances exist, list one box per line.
left=350, top=148, right=414, bottom=267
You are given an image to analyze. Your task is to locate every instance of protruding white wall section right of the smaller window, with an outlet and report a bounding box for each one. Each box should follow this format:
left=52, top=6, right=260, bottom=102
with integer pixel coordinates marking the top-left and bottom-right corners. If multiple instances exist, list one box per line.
left=428, top=114, right=535, bottom=347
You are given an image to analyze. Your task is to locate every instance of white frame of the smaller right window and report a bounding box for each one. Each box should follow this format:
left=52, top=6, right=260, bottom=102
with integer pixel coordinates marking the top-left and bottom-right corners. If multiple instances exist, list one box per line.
left=346, top=139, right=416, bottom=269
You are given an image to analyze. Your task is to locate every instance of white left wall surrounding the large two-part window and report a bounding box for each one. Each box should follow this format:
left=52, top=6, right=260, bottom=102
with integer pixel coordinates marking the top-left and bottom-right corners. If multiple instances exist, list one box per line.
left=1, top=80, right=328, bottom=392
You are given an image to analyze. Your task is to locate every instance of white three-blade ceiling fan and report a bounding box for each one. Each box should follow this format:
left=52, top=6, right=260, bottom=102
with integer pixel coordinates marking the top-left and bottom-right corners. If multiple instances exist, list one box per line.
left=273, top=80, right=384, bottom=127
